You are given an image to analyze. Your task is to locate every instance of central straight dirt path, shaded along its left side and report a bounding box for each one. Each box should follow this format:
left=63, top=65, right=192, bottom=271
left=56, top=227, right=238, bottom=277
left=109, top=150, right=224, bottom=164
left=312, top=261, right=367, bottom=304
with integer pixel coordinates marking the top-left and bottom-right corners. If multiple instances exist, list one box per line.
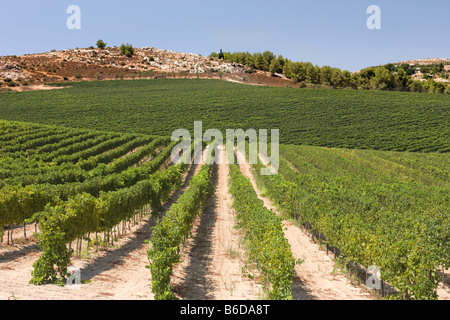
left=171, top=148, right=261, bottom=300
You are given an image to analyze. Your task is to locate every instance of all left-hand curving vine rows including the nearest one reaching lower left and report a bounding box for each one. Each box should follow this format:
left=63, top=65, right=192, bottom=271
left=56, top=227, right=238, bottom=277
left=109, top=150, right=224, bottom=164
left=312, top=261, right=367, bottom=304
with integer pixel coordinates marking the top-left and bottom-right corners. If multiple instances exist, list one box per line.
left=0, top=121, right=204, bottom=285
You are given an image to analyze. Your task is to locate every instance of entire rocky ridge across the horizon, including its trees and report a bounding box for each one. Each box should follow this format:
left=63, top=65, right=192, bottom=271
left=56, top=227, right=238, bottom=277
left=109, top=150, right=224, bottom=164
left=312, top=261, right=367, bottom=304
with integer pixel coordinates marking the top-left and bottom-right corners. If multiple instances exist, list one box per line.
left=0, top=47, right=450, bottom=93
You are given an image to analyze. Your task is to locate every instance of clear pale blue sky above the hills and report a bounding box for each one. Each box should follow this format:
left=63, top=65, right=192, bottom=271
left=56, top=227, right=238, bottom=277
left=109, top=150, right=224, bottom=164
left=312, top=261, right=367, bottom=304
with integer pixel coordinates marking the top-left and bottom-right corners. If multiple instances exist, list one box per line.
left=0, top=0, right=450, bottom=71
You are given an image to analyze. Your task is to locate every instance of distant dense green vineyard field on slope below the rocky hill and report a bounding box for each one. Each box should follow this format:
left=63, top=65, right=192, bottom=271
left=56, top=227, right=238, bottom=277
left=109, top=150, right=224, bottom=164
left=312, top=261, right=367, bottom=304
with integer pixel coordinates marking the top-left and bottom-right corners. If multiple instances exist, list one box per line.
left=0, top=79, right=450, bottom=152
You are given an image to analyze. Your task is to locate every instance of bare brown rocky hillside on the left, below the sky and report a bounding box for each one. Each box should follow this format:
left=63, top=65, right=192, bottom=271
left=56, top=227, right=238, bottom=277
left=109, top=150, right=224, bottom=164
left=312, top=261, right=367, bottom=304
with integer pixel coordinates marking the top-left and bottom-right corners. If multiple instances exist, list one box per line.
left=0, top=47, right=294, bottom=91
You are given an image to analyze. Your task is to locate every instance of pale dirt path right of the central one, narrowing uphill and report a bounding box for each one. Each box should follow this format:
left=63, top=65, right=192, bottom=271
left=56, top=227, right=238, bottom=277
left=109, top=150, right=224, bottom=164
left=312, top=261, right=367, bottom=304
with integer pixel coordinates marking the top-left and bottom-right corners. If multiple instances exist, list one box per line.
left=237, top=152, right=371, bottom=300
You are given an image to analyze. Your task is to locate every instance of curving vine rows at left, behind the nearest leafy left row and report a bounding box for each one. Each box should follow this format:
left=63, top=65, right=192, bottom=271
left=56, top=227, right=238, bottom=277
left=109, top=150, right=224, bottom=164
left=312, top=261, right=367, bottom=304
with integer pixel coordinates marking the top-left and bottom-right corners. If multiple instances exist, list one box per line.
left=0, top=121, right=177, bottom=252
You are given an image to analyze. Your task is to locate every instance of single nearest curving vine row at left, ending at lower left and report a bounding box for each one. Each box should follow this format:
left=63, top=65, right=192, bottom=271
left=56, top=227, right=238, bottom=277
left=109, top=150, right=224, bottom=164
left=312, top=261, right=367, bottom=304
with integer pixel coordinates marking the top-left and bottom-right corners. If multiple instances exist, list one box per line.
left=31, top=160, right=186, bottom=284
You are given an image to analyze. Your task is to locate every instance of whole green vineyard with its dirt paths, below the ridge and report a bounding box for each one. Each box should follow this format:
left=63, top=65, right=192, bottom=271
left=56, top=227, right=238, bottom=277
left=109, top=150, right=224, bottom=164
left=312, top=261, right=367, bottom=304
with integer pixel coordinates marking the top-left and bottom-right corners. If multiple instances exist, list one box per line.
left=0, top=79, right=450, bottom=300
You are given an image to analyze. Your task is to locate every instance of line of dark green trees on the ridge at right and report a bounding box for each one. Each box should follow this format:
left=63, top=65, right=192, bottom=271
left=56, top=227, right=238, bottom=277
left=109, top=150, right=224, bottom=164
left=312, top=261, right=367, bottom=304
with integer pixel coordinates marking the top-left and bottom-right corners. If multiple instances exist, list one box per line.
left=210, top=51, right=450, bottom=94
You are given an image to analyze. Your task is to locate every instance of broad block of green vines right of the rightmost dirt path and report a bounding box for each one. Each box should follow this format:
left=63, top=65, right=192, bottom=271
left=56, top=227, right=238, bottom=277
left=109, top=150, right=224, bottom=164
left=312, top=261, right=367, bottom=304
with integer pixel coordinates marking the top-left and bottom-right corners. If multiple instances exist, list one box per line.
left=255, top=146, right=450, bottom=299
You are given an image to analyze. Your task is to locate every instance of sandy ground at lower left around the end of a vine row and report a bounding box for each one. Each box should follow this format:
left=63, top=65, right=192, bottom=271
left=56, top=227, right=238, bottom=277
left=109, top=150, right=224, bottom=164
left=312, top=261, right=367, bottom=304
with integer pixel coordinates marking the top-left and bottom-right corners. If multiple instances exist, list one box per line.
left=0, top=151, right=201, bottom=300
